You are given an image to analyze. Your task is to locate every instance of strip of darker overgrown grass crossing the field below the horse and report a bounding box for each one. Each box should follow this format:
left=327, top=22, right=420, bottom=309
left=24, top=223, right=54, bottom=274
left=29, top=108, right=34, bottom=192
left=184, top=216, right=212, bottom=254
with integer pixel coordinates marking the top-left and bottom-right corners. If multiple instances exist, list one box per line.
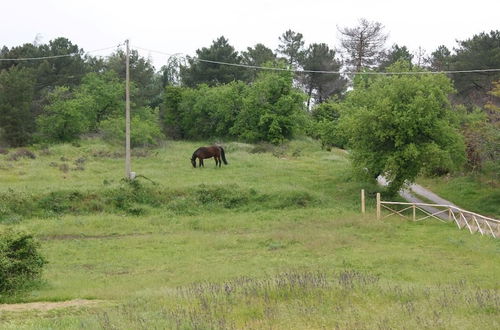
left=0, top=179, right=319, bottom=223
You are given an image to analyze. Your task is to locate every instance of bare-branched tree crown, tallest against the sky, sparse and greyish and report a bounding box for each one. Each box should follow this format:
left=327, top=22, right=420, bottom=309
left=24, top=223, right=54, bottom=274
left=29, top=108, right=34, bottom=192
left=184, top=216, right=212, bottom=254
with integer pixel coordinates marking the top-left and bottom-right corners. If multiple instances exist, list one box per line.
left=338, top=18, right=387, bottom=72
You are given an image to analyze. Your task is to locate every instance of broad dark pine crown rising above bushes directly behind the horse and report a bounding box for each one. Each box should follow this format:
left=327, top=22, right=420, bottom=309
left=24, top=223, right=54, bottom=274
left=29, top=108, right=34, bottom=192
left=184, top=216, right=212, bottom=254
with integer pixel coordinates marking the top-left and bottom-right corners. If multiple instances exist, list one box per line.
left=180, top=36, right=245, bottom=87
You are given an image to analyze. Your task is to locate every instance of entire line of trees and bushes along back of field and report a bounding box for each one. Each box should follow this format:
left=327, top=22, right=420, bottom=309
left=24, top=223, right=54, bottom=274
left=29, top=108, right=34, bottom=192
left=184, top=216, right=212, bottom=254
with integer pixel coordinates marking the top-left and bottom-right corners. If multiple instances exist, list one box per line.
left=0, top=19, right=500, bottom=191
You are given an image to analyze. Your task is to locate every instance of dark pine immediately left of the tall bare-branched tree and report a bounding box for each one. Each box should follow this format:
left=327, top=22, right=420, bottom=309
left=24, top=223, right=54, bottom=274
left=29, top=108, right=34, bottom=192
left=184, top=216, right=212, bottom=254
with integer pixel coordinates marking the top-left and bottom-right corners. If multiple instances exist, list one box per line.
left=303, top=43, right=347, bottom=108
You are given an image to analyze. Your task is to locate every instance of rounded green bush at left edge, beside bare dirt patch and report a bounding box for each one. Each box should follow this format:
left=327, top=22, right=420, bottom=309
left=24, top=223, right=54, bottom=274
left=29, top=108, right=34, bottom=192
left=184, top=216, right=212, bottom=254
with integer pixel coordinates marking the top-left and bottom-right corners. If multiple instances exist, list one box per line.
left=0, top=230, right=46, bottom=295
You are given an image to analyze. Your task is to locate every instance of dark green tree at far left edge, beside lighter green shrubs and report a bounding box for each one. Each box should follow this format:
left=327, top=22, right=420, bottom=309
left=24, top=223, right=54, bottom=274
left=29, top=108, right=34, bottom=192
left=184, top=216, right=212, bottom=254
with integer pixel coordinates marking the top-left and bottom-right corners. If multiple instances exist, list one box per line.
left=0, top=67, right=35, bottom=147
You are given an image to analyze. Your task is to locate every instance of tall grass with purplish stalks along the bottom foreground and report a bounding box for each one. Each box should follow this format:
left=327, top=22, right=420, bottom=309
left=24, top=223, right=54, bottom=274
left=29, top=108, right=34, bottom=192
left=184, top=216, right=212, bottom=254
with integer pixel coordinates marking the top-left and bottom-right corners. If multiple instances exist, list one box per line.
left=2, top=270, right=500, bottom=329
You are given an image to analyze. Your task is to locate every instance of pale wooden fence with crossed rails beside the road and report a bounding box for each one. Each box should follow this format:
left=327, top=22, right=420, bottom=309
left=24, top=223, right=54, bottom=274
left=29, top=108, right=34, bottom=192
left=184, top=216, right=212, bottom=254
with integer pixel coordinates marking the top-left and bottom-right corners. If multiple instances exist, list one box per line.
left=377, top=193, right=500, bottom=238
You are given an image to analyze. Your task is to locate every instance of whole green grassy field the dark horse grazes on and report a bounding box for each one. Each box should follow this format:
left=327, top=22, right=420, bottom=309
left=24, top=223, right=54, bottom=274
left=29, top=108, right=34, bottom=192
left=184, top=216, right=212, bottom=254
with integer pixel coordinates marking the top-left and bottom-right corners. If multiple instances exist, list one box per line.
left=0, top=140, right=500, bottom=329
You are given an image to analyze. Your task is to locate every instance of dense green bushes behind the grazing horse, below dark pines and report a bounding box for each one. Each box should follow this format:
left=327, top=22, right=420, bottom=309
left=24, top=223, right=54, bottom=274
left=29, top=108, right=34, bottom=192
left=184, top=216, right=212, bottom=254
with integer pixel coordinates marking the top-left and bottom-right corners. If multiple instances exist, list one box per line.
left=162, top=72, right=306, bottom=143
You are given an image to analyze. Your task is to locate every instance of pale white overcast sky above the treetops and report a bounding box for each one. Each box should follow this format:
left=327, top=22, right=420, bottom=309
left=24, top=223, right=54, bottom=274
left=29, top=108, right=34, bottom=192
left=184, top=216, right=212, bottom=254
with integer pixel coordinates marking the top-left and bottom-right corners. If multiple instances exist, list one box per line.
left=0, top=0, right=500, bottom=68
